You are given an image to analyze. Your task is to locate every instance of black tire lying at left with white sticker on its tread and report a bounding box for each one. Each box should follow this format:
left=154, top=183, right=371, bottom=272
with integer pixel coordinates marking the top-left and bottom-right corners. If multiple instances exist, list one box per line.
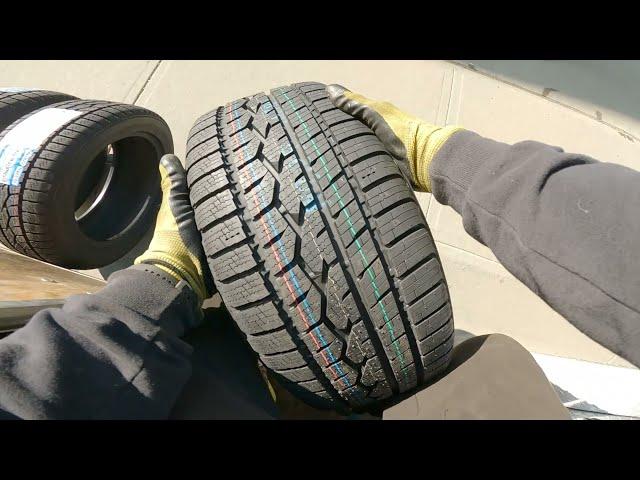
left=0, top=100, right=173, bottom=268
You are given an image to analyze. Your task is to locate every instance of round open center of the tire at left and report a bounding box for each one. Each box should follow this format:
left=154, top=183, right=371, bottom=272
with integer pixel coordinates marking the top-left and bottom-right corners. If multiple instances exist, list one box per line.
left=74, top=137, right=160, bottom=241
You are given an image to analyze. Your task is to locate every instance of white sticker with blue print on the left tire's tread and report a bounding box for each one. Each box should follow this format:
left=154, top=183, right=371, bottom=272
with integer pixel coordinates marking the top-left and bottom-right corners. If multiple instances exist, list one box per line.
left=0, top=108, right=83, bottom=186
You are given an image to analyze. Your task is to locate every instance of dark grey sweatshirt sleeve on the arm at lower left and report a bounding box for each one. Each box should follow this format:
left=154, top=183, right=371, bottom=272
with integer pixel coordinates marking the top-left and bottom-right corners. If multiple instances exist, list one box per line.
left=0, top=265, right=200, bottom=419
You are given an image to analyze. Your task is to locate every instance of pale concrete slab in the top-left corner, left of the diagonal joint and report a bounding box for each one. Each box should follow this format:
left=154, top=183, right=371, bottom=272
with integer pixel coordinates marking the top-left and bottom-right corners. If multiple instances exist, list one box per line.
left=0, top=60, right=158, bottom=103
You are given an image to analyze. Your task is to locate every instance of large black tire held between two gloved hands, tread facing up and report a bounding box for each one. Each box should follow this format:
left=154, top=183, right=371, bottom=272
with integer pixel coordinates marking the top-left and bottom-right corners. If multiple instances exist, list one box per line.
left=186, top=83, right=453, bottom=411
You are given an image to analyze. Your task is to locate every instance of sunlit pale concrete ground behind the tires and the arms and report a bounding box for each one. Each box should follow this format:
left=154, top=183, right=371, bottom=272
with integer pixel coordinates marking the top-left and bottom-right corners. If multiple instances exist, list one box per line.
left=0, top=61, right=640, bottom=367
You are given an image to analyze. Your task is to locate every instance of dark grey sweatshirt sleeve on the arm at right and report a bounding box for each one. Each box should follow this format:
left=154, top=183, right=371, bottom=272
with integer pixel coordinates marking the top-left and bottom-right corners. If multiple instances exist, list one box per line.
left=430, top=131, right=640, bottom=366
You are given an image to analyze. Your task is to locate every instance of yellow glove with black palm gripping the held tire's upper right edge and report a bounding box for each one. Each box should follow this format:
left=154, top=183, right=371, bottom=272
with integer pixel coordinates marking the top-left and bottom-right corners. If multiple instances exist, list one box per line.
left=327, top=84, right=462, bottom=192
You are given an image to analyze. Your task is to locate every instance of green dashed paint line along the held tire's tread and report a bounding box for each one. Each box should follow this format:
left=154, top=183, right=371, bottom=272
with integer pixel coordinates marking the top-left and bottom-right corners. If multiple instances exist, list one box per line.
left=278, top=89, right=408, bottom=381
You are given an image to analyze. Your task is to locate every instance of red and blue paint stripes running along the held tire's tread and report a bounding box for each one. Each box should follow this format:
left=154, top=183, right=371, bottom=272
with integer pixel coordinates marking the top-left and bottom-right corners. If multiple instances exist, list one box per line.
left=226, top=105, right=360, bottom=398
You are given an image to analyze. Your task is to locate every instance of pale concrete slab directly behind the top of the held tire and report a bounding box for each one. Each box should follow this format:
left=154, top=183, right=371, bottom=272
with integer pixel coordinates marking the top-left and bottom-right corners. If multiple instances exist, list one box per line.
left=138, top=60, right=453, bottom=158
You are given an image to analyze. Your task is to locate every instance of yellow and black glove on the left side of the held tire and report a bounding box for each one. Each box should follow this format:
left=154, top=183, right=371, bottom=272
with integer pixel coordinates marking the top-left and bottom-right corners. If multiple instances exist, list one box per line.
left=134, top=155, right=215, bottom=303
